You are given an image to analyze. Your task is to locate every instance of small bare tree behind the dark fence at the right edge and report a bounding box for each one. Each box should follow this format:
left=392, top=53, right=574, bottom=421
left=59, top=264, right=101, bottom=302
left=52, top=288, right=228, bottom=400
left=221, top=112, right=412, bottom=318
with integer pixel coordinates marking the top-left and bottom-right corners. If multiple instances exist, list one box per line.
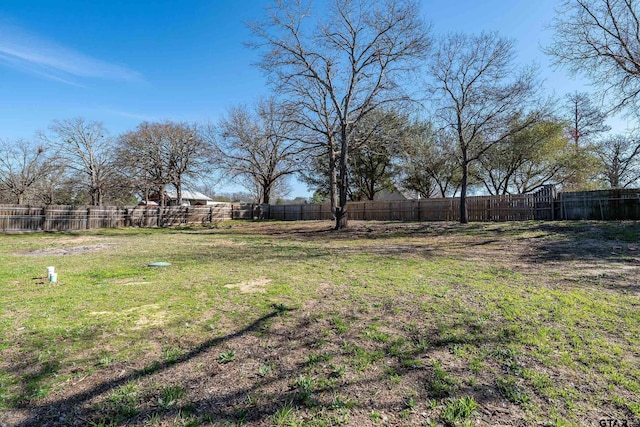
left=597, top=135, right=640, bottom=188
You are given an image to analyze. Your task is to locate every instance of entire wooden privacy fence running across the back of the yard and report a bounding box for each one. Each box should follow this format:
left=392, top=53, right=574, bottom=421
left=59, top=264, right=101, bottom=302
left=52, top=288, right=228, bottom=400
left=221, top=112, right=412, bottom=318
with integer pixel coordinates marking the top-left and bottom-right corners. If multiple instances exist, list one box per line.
left=0, top=186, right=640, bottom=233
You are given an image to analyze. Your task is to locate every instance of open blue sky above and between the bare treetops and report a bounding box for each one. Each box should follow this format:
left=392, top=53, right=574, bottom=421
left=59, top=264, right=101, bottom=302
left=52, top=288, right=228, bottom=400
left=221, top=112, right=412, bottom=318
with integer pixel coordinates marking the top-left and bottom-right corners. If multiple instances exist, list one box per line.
left=0, top=0, right=612, bottom=196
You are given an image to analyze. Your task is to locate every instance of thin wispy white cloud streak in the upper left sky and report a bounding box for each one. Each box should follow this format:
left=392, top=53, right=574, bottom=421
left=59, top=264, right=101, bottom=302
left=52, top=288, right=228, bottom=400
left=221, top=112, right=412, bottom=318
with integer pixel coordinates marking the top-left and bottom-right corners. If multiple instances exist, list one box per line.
left=0, top=22, right=142, bottom=86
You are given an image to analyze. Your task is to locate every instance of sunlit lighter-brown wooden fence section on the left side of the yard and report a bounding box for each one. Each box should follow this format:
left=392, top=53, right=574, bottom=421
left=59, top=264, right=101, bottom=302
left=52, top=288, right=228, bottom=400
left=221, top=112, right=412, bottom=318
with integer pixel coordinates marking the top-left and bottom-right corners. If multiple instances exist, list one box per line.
left=0, top=203, right=260, bottom=233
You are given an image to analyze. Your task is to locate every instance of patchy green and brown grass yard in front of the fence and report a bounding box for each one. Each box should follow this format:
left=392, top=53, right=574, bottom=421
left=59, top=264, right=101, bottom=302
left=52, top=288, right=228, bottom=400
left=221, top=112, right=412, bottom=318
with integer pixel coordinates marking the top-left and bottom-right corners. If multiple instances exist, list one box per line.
left=0, top=222, right=640, bottom=426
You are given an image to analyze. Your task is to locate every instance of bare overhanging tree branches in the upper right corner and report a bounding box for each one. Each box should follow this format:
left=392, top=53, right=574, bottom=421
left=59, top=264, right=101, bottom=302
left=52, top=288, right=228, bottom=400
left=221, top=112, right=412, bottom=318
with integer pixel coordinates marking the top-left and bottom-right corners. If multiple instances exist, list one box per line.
left=544, top=0, right=640, bottom=108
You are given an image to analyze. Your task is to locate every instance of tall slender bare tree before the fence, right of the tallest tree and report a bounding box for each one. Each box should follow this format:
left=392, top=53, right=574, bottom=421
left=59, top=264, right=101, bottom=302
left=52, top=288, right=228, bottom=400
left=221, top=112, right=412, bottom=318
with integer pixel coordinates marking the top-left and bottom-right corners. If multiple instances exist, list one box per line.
left=430, top=33, right=537, bottom=223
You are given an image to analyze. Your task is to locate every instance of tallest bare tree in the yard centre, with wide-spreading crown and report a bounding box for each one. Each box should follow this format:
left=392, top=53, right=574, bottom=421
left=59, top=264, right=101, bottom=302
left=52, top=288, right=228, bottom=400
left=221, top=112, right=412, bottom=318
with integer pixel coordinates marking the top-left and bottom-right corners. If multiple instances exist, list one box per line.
left=252, top=0, right=429, bottom=228
